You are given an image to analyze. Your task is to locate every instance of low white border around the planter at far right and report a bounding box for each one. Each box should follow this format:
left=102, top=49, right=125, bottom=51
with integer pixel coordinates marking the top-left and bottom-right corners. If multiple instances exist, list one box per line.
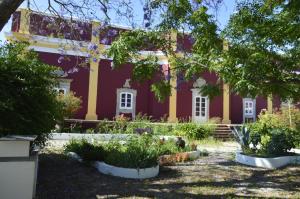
left=235, top=151, right=300, bottom=169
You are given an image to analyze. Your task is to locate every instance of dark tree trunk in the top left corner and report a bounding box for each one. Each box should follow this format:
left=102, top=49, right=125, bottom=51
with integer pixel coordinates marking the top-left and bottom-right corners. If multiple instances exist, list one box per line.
left=0, top=0, right=24, bottom=32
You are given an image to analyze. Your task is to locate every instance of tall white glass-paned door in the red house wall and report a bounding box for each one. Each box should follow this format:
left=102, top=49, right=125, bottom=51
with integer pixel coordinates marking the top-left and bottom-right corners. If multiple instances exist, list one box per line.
left=193, top=96, right=208, bottom=123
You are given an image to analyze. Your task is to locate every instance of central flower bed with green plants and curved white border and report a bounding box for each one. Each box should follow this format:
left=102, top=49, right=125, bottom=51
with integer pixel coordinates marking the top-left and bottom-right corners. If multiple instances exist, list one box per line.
left=65, top=135, right=200, bottom=179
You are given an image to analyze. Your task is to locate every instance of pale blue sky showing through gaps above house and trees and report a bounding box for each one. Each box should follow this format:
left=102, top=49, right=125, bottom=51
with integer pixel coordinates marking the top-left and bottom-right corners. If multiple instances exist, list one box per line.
left=0, top=0, right=235, bottom=43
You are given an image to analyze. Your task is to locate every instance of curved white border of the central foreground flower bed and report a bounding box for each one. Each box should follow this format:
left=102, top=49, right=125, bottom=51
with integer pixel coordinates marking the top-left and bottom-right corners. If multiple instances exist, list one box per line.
left=67, top=152, right=159, bottom=179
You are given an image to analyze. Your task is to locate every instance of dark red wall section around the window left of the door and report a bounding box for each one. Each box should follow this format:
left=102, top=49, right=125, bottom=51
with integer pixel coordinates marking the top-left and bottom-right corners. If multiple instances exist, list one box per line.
left=96, top=59, right=168, bottom=119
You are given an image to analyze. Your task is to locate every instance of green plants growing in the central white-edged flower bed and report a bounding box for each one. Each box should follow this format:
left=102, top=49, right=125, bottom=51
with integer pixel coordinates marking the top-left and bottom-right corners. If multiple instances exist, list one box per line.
left=65, top=135, right=195, bottom=168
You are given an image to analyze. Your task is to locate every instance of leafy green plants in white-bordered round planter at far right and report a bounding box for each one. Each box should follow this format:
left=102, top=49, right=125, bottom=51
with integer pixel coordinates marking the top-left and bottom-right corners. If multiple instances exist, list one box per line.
left=235, top=109, right=300, bottom=169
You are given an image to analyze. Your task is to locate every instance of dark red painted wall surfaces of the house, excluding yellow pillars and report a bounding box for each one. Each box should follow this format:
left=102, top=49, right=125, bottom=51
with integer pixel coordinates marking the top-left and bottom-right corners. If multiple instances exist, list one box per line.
left=11, top=12, right=281, bottom=123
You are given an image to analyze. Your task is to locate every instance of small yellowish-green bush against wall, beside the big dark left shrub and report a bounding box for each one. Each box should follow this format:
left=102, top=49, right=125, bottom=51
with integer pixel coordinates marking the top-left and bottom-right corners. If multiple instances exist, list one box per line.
left=57, top=91, right=82, bottom=118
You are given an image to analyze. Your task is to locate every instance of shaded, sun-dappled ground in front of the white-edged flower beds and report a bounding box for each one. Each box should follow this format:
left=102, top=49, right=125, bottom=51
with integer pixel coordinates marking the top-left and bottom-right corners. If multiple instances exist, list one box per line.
left=37, top=142, right=300, bottom=199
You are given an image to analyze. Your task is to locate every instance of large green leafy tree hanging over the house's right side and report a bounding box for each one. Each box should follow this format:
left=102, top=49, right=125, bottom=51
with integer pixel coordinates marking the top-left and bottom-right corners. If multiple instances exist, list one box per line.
left=108, top=0, right=300, bottom=101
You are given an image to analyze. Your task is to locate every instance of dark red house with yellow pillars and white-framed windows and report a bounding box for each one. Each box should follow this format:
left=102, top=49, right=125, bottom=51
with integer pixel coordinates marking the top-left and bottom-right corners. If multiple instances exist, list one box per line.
left=6, top=9, right=280, bottom=124
